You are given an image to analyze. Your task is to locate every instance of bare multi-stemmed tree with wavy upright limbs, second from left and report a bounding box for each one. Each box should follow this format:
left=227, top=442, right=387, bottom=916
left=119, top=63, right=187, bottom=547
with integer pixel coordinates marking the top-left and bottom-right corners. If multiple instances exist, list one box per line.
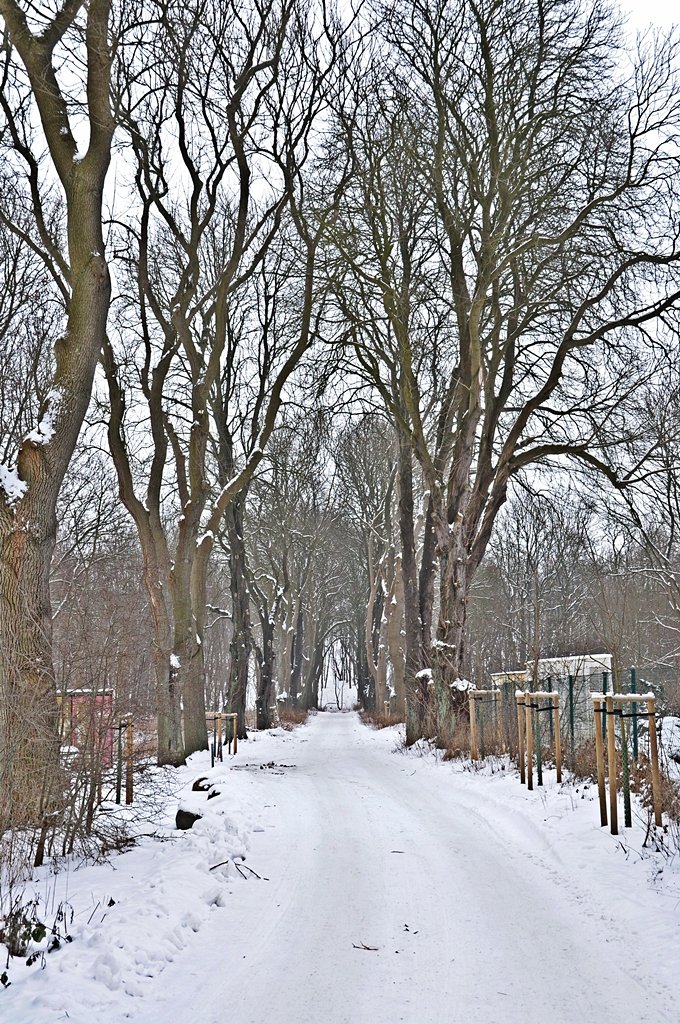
left=105, top=0, right=350, bottom=763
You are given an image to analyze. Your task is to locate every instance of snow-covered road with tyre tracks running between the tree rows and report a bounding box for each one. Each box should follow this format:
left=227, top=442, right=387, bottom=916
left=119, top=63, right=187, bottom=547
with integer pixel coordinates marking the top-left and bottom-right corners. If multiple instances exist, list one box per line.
left=144, top=715, right=678, bottom=1024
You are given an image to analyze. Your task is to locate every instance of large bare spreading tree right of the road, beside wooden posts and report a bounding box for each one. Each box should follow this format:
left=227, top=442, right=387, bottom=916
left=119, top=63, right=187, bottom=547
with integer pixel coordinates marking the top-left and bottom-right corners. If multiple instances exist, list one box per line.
left=331, top=0, right=680, bottom=733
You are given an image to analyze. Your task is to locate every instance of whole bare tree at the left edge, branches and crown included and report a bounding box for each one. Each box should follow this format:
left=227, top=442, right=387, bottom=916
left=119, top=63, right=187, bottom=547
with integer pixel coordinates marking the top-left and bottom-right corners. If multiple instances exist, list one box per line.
left=0, top=0, right=114, bottom=815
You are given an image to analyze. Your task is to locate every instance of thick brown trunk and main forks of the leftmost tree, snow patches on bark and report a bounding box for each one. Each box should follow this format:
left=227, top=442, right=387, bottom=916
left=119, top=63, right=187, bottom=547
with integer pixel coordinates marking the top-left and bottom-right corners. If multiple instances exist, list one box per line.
left=0, top=0, right=114, bottom=827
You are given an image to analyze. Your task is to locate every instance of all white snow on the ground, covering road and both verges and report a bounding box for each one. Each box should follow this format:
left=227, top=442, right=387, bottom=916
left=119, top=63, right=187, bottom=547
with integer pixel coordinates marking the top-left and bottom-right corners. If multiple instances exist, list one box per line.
left=0, top=714, right=680, bottom=1024
